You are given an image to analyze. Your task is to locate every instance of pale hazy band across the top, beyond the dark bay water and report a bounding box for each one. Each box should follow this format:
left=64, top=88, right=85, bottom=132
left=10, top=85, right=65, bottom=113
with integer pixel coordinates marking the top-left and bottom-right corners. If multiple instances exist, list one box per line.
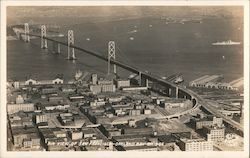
left=7, top=6, right=243, bottom=25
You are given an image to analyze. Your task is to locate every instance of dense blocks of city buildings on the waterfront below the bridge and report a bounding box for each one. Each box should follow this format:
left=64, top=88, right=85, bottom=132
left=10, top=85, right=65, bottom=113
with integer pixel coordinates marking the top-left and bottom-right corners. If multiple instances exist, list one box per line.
left=7, top=71, right=244, bottom=151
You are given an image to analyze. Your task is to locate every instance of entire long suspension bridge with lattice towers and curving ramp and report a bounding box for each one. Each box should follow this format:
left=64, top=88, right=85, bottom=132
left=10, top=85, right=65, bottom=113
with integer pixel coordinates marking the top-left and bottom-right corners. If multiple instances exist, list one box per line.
left=16, top=23, right=244, bottom=136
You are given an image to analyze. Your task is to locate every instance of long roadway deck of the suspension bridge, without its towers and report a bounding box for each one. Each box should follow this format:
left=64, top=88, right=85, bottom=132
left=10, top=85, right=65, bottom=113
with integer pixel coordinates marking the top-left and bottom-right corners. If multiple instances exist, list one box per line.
left=20, top=33, right=244, bottom=133
